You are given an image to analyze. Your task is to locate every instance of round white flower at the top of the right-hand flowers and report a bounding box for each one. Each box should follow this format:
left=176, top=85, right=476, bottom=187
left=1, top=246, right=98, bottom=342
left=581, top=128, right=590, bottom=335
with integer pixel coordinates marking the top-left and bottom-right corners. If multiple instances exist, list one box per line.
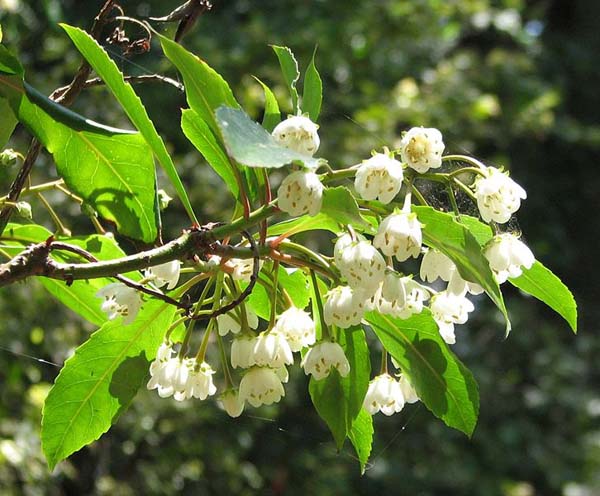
left=400, top=127, right=444, bottom=173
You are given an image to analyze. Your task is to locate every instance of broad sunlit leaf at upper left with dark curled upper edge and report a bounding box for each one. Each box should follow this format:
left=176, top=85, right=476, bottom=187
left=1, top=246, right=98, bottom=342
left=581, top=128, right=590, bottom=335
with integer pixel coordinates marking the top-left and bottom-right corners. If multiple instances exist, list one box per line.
left=0, top=60, right=158, bottom=243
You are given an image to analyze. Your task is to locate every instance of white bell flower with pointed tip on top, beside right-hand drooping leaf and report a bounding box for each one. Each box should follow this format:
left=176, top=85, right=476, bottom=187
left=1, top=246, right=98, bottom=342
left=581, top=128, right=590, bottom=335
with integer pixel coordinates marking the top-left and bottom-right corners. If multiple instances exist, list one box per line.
left=373, top=202, right=423, bottom=262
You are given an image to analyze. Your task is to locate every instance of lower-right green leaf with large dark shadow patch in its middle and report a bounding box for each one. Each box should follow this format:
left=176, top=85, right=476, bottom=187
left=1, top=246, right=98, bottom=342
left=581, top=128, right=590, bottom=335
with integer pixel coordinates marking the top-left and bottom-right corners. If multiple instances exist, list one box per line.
left=366, top=310, right=479, bottom=436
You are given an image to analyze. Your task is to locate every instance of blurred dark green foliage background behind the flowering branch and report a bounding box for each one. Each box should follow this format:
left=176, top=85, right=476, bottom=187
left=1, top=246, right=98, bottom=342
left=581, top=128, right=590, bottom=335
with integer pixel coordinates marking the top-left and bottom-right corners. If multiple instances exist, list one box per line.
left=0, top=0, right=600, bottom=496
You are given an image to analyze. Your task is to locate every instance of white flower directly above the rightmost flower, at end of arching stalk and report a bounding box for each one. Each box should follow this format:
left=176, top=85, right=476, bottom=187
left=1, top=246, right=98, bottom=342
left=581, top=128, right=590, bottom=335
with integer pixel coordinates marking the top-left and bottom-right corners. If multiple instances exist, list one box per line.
left=474, top=167, right=527, bottom=224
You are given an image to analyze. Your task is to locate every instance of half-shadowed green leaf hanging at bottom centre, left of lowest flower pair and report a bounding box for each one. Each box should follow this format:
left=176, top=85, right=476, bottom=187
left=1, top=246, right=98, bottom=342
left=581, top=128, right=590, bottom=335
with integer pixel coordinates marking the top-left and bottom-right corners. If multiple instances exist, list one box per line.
left=308, top=328, right=371, bottom=450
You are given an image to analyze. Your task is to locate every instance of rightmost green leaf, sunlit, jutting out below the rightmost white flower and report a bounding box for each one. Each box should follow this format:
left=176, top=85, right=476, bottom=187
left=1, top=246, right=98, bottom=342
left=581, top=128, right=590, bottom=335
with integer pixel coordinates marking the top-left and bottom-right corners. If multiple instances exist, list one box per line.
left=509, top=261, right=577, bottom=333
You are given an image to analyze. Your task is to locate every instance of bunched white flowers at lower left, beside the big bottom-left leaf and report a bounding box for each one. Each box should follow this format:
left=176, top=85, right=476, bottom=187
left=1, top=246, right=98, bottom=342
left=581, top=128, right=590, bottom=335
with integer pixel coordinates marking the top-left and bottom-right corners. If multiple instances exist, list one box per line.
left=147, top=343, right=217, bottom=401
